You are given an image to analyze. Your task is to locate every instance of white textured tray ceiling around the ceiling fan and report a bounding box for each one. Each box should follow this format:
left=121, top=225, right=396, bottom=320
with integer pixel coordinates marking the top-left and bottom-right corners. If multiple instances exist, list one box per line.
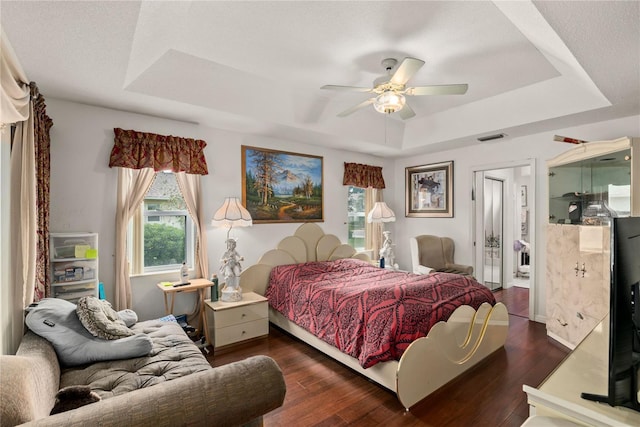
left=0, top=0, right=640, bottom=156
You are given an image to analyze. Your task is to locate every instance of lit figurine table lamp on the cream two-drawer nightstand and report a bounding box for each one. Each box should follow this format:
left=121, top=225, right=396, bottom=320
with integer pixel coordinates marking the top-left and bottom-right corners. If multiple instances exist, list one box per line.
left=211, top=197, right=253, bottom=302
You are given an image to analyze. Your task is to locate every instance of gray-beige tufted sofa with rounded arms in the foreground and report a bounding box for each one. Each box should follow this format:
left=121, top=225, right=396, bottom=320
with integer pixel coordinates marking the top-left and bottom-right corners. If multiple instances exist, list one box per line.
left=0, top=321, right=286, bottom=427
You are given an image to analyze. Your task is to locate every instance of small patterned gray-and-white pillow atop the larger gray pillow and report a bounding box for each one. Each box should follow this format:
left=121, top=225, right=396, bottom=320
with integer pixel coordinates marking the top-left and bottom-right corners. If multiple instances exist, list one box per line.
left=76, top=297, right=135, bottom=340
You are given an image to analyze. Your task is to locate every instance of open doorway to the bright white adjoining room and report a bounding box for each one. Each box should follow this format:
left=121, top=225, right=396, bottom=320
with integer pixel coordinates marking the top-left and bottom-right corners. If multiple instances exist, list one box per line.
left=473, top=160, right=535, bottom=319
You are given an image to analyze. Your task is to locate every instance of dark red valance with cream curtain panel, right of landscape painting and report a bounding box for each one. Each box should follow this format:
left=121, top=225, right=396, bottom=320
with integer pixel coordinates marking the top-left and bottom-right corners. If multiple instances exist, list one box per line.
left=342, top=162, right=385, bottom=258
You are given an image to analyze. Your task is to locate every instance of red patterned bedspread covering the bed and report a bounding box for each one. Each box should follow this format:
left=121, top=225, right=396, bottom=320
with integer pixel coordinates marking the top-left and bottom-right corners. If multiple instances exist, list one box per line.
left=265, top=259, right=496, bottom=368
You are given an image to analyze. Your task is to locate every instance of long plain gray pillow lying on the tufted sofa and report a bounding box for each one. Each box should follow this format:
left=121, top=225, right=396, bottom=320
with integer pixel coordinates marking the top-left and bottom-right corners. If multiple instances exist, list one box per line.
left=25, top=298, right=152, bottom=366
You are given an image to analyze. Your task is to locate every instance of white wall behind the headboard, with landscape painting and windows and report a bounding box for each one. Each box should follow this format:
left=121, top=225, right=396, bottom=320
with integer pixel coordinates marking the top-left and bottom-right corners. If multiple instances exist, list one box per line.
left=47, top=98, right=394, bottom=319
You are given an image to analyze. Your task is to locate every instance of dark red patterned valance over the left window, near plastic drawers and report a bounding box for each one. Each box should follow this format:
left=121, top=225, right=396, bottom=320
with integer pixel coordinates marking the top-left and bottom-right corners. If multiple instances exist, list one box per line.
left=109, top=128, right=209, bottom=175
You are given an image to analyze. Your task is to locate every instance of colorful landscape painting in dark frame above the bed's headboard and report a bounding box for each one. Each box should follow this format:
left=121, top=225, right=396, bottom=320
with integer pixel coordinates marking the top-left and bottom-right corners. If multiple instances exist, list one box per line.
left=241, top=145, right=324, bottom=224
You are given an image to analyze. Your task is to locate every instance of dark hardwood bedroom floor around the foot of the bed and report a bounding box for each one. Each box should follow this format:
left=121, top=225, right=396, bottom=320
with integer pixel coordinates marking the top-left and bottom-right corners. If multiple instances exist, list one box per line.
left=208, top=315, right=568, bottom=427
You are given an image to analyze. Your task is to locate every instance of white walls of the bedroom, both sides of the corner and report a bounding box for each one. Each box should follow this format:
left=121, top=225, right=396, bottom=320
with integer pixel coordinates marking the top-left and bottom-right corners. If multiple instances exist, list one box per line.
left=33, top=99, right=640, bottom=321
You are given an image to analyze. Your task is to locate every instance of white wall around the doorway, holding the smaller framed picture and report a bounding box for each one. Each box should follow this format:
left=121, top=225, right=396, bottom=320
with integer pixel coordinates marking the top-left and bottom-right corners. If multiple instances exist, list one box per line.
left=387, top=116, right=640, bottom=321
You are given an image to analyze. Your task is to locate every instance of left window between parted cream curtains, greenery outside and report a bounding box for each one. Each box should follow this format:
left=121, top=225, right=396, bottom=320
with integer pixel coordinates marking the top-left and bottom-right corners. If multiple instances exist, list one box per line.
left=127, top=172, right=195, bottom=274
